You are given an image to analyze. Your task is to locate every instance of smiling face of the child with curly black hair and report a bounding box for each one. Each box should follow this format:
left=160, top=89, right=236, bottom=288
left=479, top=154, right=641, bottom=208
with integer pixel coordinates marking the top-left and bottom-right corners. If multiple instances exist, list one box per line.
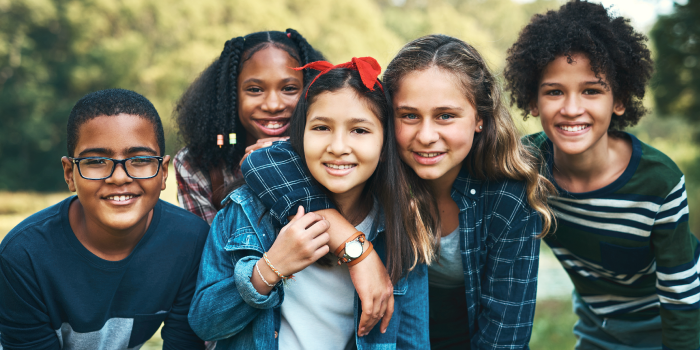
left=532, top=54, right=625, bottom=155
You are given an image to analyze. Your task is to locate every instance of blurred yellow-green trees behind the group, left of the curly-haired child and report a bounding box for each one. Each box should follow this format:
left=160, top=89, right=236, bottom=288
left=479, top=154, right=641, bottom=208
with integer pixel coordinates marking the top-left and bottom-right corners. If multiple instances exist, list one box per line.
left=0, top=0, right=557, bottom=191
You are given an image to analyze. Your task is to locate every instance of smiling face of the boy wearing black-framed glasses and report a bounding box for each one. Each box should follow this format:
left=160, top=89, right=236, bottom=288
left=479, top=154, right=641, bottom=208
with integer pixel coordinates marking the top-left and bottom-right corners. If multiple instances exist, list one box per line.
left=62, top=114, right=170, bottom=232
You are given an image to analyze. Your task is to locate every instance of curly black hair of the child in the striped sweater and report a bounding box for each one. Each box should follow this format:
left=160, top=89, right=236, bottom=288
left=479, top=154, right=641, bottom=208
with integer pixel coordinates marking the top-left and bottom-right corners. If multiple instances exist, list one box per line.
left=504, top=1, right=653, bottom=131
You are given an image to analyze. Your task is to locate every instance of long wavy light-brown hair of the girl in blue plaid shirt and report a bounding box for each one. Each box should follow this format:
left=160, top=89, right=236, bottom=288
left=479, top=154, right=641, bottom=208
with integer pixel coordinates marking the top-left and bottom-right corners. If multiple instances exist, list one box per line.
left=384, top=34, right=556, bottom=237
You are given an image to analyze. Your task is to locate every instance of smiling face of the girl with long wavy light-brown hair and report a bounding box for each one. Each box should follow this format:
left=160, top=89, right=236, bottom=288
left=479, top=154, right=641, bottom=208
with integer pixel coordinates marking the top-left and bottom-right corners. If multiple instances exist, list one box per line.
left=393, top=66, right=482, bottom=184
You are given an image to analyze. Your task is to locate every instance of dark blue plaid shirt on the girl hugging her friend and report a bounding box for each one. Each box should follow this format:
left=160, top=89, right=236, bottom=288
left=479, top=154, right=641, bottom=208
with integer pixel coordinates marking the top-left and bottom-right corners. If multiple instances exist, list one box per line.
left=241, top=141, right=542, bottom=349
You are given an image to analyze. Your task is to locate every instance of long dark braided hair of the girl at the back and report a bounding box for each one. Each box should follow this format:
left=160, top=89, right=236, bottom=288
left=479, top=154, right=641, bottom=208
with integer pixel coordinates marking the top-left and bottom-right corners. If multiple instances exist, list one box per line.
left=173, top=29, right=324, bottom=172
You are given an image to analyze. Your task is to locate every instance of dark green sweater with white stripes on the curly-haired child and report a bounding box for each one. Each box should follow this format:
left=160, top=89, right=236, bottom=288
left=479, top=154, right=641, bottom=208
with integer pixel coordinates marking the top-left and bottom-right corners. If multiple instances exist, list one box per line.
left=525, top=133, right=700, bottom=349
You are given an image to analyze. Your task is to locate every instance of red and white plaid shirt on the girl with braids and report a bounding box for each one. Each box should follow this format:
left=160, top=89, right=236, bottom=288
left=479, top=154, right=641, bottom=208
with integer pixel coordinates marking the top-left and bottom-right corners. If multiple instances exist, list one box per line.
left=173, top=148, right=240, bottom=225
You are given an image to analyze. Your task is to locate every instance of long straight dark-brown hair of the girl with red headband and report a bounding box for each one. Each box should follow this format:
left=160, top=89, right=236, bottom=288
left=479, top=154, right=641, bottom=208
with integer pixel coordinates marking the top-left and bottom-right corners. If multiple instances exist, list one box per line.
left=290, top=68, right=437, bottom=284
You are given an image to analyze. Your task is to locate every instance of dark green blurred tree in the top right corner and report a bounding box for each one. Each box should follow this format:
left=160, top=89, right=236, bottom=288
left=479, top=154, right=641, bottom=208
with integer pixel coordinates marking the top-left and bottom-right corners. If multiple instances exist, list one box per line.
left=651, top=0, right=700, bottom=123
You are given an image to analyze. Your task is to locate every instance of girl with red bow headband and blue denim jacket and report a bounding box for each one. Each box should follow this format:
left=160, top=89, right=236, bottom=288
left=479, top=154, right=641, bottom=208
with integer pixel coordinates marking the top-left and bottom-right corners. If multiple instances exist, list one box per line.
left=189, top=57, right=438, bottom=350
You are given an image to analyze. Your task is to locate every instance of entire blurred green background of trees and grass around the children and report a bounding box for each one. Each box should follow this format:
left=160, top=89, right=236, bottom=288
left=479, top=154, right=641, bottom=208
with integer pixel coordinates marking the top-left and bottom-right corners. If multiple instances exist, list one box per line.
left=0, top=0, right=700, bottom=349
